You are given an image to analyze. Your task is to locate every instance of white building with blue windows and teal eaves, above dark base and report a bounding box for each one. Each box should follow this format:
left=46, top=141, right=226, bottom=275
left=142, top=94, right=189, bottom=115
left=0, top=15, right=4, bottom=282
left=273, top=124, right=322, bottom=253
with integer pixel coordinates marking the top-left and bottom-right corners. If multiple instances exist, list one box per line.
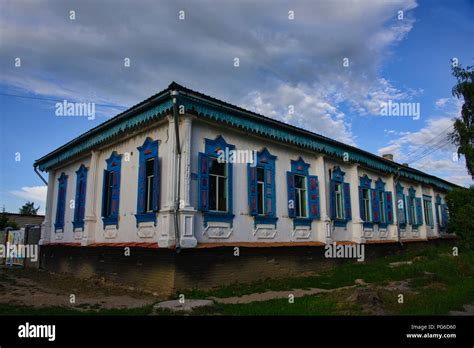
left=34, top=83, right=455, bottom=248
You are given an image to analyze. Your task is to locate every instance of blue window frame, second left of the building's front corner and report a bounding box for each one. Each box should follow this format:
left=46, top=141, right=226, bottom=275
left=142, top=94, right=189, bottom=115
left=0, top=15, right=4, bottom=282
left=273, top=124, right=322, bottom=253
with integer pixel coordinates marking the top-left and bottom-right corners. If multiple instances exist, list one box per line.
left=102, top=151, right=122, bottom=228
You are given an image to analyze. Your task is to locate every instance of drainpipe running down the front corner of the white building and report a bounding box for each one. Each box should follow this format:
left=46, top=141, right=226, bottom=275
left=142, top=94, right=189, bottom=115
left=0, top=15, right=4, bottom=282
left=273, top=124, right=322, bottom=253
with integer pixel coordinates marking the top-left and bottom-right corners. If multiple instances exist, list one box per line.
left=170, top=91, right=181, bottom=253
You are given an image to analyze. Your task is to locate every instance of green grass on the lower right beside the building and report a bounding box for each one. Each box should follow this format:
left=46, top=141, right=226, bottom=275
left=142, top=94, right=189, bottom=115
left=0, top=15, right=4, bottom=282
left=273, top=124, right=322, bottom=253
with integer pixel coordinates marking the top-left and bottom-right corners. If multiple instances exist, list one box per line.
left=175, top=246, right=474, bottom=315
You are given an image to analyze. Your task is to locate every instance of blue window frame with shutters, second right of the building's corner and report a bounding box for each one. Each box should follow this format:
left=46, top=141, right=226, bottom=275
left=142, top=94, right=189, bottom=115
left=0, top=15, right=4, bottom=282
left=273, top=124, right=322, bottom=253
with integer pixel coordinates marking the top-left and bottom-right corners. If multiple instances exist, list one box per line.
left=247, top=148, right=278, bottom=224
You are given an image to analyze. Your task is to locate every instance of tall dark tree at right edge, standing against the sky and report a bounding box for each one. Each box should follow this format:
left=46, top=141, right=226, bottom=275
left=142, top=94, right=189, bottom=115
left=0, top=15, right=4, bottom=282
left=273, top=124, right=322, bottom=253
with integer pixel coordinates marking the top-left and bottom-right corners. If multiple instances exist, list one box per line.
left=449, top=65, right=474, bottom=178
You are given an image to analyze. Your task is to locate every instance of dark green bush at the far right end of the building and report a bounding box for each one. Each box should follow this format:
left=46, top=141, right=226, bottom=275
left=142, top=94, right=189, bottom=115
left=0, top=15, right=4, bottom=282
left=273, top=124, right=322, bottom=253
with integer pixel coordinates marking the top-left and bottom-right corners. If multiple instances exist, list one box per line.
left=446, top=186, right=474, bottom=247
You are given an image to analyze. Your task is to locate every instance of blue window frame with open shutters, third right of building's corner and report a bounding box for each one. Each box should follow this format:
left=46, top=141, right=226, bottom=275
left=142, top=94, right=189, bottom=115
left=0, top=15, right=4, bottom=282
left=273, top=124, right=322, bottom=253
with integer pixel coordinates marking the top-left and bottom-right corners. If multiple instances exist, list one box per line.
left=287, top=157, right=321, bottom=227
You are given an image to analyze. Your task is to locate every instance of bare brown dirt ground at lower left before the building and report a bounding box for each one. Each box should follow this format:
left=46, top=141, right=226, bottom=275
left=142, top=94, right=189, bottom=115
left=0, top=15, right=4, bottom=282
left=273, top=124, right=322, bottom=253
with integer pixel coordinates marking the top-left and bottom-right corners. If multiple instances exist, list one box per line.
left=0, top=268, right=160, bottom=310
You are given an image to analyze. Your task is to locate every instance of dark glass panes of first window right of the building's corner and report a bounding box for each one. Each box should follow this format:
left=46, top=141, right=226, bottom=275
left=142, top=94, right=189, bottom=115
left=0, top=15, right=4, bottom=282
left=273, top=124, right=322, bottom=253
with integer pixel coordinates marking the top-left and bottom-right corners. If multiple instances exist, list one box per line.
left=209, top=158, right=227, bottom=213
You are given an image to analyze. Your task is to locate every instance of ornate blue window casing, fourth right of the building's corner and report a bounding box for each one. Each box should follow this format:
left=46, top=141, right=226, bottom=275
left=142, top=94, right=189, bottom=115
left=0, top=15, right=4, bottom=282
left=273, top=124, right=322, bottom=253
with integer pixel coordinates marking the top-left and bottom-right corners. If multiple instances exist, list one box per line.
left=329, top=167, right=352, bottom=227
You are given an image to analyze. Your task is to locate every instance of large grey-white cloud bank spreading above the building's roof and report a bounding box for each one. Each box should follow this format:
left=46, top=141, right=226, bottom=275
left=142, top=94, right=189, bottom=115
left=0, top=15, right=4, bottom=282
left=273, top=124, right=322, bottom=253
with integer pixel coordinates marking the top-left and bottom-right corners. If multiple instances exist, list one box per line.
left=0, top=0, right=417, bottom=144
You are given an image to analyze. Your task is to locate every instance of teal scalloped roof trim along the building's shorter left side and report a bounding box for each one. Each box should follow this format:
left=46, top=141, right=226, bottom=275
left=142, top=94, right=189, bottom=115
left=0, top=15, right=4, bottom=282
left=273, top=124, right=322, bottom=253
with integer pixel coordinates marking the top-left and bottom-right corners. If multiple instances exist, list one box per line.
left=37, top=99, right=173, bottom=171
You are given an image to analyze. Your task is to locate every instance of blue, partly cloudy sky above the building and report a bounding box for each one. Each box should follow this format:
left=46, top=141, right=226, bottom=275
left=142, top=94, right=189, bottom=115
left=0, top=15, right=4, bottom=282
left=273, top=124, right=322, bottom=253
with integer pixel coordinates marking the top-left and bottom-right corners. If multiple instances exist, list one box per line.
left=0, top=0, right=474, bottom=213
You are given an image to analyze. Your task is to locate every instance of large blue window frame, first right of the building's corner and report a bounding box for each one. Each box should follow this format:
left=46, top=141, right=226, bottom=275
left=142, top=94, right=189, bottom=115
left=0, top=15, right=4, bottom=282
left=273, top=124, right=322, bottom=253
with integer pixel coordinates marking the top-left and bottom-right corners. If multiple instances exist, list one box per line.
left=198, top=135, right=235, bottom=225
